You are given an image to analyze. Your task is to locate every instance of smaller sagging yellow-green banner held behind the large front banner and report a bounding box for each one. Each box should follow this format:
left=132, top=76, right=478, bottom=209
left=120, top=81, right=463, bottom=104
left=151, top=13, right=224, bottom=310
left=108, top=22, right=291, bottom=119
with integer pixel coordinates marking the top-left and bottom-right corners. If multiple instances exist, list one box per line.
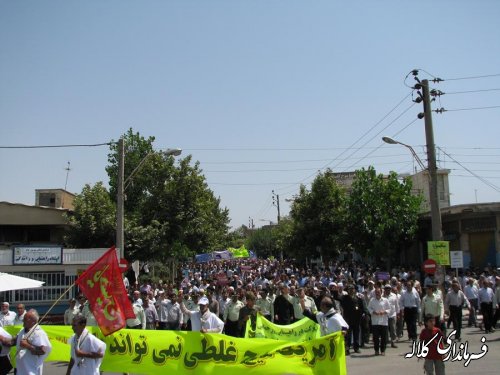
left=245, top=314, right=320, bottom=342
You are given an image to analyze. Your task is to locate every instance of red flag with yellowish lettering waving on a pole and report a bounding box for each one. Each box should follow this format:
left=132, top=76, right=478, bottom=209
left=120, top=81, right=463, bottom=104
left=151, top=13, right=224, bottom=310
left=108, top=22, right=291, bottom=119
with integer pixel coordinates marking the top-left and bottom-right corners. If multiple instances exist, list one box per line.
left=76, top=246, right=135, bottom=336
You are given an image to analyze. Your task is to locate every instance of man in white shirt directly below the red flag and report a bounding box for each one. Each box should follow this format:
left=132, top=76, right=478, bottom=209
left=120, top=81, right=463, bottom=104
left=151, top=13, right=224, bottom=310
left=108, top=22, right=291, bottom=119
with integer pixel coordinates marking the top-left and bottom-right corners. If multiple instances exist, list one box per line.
left=66, top=315, right=106, bottom=375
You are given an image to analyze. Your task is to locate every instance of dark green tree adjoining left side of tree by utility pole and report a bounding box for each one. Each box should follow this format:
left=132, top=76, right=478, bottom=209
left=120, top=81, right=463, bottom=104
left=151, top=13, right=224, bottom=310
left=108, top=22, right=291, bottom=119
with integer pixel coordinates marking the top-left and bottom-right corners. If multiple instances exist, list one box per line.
left=290, top=169, right=346, bottom=259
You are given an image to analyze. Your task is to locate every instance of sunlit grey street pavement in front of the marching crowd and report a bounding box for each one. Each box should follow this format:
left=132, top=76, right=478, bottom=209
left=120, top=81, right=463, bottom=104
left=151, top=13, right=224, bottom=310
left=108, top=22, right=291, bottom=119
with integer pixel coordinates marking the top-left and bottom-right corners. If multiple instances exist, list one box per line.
left=30, top=328, right=500, bottom=375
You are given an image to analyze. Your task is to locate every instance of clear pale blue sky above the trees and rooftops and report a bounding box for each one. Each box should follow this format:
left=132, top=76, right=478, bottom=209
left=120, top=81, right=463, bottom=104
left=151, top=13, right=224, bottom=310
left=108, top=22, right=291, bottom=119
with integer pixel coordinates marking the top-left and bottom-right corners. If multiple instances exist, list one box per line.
left=0, top=0, right=500, bottom=227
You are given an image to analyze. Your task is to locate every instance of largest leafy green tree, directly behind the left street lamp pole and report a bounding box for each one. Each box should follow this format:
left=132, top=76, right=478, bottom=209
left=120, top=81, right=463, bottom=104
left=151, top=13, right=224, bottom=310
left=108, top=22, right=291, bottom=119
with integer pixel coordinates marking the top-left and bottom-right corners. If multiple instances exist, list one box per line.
left=106, top=129, right=229, bottom=261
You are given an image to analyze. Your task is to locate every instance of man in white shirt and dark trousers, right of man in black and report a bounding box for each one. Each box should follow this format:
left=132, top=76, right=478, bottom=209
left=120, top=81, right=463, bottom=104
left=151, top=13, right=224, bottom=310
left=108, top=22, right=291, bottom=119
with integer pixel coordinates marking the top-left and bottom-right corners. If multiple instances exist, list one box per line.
left=368, top=288, right=391, bottom=355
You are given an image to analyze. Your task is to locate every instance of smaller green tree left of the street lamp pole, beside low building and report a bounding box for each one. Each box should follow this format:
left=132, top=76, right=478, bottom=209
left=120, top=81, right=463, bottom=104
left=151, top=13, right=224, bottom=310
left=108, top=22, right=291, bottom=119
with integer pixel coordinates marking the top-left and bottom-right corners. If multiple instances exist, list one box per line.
left=65, top=182, right=115, bottom=248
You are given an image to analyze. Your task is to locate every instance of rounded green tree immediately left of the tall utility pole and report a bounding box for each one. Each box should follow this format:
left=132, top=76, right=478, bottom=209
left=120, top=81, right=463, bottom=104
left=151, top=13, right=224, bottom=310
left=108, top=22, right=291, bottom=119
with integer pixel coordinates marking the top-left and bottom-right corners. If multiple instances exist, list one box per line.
left=347, top=167, right=421, bottom=265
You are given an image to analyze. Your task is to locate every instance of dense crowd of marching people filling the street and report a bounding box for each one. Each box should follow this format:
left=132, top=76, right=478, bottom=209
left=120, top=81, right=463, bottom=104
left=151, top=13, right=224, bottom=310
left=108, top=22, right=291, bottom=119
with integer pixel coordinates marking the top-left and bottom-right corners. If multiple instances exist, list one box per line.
left=0, top=259, right=500, bottom=375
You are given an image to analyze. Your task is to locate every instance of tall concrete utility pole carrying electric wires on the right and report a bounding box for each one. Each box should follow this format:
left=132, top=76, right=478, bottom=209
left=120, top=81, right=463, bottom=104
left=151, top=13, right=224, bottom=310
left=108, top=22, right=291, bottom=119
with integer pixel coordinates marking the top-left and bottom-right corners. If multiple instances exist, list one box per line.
left=420, top=79, right=443, bottom=241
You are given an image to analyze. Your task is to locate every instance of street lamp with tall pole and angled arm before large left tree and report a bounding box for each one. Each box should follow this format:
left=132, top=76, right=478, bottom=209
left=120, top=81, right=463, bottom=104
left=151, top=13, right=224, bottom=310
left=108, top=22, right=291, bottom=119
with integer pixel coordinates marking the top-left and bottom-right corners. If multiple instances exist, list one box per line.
left=116, top=138, right=182, bottom=259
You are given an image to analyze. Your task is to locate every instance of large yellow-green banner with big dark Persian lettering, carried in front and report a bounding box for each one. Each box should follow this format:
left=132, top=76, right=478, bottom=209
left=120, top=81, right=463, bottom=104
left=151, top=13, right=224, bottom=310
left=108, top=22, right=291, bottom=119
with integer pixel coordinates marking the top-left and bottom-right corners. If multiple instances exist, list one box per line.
left=5, top=326, right=347, bottom=375
